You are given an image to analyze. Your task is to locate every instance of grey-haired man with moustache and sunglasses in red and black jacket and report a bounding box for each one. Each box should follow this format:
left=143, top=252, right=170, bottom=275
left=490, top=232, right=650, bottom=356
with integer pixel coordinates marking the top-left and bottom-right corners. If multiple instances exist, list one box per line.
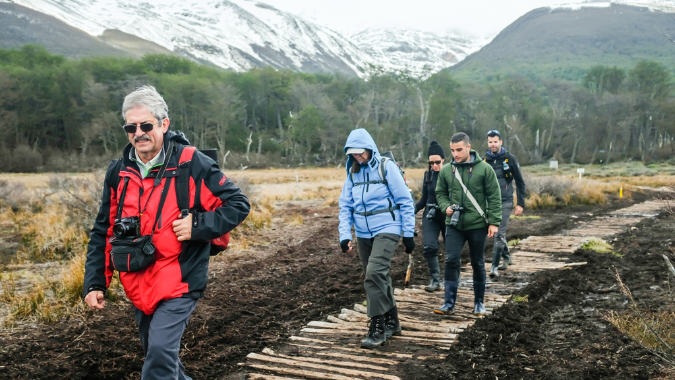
left=84, top=86, right=250, bottom=380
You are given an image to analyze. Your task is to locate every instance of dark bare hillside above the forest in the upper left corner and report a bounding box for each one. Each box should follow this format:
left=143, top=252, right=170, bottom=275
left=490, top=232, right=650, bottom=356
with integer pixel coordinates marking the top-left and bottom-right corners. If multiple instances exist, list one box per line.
left=0, top=2, right=135, bottom=58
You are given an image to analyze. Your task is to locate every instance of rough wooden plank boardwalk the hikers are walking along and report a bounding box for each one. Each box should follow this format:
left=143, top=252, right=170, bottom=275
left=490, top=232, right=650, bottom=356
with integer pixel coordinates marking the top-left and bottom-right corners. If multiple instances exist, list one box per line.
left=240, top=201, right=665, bottom=380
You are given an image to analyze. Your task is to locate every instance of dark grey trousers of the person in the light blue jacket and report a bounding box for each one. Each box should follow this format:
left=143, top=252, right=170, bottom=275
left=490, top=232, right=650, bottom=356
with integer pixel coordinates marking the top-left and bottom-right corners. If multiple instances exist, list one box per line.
left=357, top=234, right=400, bottom=318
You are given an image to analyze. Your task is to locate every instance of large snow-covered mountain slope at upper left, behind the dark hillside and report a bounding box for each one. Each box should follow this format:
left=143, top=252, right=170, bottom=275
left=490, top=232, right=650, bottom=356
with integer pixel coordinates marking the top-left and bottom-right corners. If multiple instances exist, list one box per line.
left=0, top=0, right=371, bottom=75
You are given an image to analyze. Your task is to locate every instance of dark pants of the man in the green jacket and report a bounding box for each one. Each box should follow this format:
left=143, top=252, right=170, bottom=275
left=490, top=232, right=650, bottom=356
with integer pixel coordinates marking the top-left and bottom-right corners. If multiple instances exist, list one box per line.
left=445, top=226, right=487, bottom=282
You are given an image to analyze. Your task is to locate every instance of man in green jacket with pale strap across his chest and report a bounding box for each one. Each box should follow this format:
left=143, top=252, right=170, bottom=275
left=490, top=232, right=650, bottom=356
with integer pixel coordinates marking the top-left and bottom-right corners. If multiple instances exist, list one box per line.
left=434, top=132, right=502, bottom=315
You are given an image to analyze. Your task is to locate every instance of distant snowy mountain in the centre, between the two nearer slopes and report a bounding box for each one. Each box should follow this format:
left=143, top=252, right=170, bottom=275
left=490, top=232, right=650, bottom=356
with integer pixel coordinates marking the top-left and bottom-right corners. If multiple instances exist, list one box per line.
left=352, top=29, right=490, bottom=78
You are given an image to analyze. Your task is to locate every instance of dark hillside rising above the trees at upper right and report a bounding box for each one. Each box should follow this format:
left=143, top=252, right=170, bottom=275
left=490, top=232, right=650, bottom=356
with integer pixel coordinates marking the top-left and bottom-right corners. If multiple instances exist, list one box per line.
left=447, top=4, right=675, bottom=80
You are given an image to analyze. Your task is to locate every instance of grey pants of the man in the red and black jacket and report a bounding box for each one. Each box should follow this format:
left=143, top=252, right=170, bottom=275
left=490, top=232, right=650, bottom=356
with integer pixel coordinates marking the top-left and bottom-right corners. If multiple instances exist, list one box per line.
left=134, top=298, right=197, bottom=380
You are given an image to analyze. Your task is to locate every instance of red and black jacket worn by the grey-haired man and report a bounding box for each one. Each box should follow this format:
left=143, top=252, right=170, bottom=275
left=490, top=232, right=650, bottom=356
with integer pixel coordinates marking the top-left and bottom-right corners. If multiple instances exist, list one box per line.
left=84, top=131, right=250, bottom=314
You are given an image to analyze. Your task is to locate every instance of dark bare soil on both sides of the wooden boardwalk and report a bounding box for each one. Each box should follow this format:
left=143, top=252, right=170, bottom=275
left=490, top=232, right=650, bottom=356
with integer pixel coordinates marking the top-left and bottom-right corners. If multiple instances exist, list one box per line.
left=0, top=193, right=664, bottom=379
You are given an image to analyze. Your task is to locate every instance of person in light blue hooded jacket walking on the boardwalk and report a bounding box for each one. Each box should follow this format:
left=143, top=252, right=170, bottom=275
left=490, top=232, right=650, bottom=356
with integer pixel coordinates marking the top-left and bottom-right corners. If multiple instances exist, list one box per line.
left=339, top=129, right=415, bottom=348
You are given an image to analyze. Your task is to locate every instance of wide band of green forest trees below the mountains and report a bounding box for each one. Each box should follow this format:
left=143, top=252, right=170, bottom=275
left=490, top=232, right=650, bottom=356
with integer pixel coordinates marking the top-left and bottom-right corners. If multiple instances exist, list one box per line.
left=0, top=45, right=675, bottom=172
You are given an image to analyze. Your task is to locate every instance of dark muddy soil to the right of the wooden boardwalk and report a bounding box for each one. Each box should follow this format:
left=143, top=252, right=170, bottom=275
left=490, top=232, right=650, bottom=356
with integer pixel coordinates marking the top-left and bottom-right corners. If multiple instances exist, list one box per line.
left=400, top=194, right=675, bottom=380
